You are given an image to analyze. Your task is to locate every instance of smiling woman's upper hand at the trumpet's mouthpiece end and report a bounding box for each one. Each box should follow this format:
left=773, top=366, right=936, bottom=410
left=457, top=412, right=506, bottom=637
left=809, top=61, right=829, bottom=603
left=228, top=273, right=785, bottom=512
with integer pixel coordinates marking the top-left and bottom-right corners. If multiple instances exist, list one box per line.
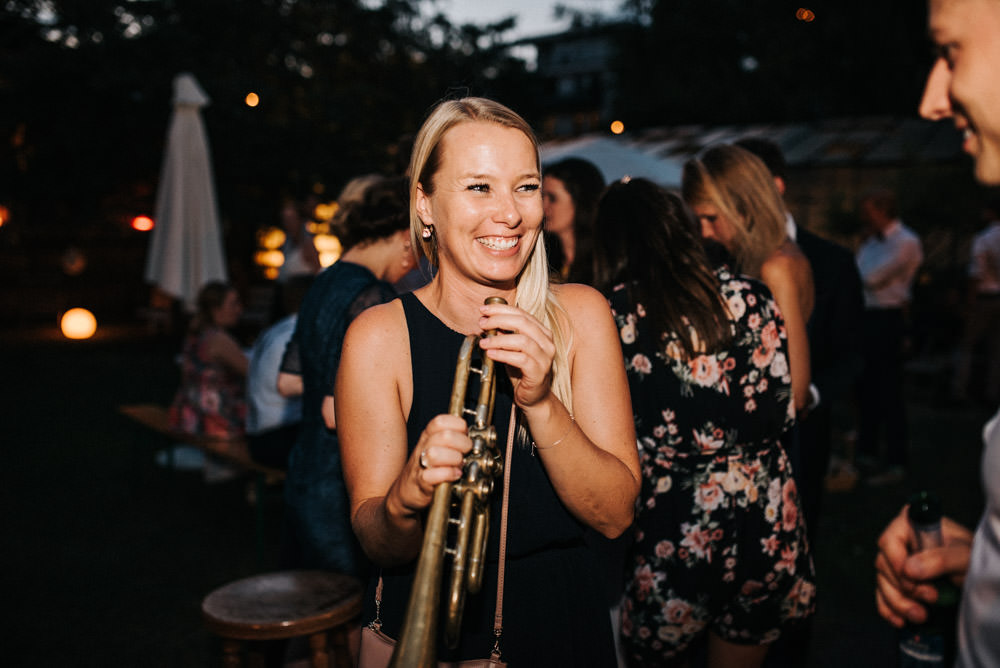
left=479, top=304, right=556, bottom=408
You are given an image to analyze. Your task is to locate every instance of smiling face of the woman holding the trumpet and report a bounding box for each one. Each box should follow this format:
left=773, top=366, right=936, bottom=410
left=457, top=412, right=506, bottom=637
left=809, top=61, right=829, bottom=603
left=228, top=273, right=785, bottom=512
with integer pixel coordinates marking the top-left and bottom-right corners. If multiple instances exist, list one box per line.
left=416, top=121, right=542, bottom=286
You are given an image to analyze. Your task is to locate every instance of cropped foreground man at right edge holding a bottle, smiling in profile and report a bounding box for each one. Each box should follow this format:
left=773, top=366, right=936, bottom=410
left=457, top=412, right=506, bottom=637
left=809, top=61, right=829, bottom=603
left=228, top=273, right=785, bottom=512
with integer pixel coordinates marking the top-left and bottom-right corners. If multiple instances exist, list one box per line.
left=875, top=0, right=1000, bottom=668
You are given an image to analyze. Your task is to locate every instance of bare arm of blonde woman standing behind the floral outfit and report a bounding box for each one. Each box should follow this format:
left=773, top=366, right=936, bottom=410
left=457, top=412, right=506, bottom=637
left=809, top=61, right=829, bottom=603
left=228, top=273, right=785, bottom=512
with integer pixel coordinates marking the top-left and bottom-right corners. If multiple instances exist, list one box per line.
left=760, top=251, right=813, bottom=413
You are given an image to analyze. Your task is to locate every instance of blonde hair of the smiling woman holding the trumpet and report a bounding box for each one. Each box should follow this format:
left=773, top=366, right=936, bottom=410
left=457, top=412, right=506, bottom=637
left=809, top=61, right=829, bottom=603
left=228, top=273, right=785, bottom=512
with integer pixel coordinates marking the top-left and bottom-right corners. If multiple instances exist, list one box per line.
left=408, top=97, right=573, bottom=411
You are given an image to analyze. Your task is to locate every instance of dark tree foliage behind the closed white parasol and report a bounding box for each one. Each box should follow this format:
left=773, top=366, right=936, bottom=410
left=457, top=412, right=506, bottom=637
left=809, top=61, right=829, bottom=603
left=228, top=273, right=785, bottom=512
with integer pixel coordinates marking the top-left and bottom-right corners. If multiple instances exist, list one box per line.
left=0, top=0, right=530, bottom=235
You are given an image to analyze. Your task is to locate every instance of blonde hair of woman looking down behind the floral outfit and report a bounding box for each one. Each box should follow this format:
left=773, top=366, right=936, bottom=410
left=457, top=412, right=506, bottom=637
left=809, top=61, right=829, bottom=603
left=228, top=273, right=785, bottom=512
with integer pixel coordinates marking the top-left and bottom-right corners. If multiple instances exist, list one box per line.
left=682, top=144, right=788, bottom=278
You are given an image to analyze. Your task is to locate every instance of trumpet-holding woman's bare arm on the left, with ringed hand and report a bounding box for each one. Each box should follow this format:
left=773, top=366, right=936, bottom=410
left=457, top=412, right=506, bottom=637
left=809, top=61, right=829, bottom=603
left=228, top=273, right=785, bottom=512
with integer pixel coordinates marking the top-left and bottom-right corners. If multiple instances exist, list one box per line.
left=334, top=301, right=472, bottom=566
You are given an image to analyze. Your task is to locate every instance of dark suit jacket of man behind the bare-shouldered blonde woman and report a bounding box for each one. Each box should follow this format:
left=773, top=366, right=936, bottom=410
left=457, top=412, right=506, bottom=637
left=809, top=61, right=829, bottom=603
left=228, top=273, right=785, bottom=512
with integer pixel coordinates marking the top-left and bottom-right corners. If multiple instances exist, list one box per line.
left=796, top=227, right=864, bottom=406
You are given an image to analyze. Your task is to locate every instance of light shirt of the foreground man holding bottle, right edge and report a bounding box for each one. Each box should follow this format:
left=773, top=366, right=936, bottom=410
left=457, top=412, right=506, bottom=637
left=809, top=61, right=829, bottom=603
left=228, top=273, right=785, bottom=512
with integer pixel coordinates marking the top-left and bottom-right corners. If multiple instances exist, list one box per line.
left=955, top=411, right=1000, bottom=668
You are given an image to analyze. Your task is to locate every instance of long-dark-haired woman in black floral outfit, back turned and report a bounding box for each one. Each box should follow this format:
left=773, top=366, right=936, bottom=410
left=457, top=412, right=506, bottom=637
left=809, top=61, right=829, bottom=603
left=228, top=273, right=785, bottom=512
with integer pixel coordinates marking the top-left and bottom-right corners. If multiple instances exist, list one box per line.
left=594, top=179, right=815, bottom=668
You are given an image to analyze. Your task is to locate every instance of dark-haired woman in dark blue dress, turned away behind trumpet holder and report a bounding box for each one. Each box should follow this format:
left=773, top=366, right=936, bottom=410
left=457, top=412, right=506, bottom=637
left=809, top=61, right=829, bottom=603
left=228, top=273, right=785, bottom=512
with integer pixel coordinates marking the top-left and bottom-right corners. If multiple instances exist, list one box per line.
left=278, top=177, right=416, bottom=577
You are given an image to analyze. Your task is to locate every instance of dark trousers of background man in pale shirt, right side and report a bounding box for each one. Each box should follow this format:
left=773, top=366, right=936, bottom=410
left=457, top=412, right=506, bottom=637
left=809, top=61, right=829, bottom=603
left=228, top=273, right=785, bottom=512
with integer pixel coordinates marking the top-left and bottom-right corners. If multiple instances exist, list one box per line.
left=858, top=309, right=908, bottom=467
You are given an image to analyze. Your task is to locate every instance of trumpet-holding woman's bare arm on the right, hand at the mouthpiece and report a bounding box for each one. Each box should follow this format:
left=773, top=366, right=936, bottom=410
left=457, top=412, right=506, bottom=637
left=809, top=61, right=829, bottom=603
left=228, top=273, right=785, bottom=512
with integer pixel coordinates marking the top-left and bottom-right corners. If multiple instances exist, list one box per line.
left=480, top=284, right=639, bottom=538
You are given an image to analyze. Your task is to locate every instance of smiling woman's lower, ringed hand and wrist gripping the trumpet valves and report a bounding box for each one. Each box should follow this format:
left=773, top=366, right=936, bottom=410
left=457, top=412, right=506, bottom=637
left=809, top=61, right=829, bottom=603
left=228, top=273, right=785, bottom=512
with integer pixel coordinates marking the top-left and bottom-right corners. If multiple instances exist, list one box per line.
left=386, top=414, right=472, bottom=517
